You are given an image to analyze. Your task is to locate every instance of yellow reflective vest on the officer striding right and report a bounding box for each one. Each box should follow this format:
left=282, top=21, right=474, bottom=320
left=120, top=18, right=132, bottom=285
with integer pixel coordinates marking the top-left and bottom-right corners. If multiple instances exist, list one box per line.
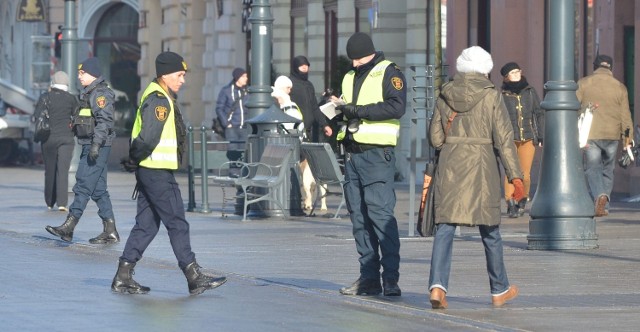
left=131, top=82, right=178, bottom=169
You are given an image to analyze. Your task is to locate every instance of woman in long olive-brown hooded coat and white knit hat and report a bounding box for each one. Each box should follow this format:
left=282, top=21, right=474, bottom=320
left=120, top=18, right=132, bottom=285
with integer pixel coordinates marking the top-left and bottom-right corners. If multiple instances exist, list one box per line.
left=429, top=46, right=525, bottom=309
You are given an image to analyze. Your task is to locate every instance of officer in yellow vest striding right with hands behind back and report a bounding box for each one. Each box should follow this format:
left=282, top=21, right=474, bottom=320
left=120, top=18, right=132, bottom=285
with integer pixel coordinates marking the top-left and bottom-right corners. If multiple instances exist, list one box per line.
left=111, top=52, right=227, bottom=295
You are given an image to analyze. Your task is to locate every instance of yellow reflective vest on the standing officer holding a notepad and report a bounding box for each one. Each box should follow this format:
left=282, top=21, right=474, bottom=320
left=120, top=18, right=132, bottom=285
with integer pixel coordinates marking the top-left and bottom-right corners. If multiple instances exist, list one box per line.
left=337, top=60, right=400, bottom=146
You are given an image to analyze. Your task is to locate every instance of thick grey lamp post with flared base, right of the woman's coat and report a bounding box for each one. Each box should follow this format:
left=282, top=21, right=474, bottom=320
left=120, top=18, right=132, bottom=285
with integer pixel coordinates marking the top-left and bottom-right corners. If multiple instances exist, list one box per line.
left=527, top=0, right=598, bottom=250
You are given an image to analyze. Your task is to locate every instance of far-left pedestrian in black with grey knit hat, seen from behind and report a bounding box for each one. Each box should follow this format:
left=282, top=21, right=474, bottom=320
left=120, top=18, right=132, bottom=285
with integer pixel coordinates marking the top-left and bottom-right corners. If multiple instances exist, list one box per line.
left=34, top=71, right=78, bottom=212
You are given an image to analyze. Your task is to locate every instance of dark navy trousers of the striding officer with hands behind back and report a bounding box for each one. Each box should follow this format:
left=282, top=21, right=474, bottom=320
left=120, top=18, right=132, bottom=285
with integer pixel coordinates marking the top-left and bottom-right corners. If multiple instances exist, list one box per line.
left=120, top=167, right=196, bottom=270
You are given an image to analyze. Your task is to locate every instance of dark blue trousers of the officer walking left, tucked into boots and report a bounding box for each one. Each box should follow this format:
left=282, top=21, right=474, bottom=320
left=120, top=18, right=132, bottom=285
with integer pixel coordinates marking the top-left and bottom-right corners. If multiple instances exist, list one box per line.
left=69, top=144, right=115, bottom=220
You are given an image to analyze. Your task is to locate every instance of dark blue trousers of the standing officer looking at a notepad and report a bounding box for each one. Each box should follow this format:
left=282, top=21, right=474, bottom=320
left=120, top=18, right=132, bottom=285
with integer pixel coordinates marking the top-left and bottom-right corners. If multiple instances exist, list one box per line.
left=344, top=148, right=400, bottom=281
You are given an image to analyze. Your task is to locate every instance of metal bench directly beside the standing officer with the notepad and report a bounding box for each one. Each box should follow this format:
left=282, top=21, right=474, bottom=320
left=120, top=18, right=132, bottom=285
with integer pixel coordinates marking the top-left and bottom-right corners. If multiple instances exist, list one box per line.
left=300, top=142, right=345, bottom=219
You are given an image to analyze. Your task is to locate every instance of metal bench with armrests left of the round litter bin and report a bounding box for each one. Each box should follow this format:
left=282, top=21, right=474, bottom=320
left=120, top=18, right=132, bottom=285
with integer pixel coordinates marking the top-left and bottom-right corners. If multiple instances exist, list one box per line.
left=209, top=144, right=293, bottom=221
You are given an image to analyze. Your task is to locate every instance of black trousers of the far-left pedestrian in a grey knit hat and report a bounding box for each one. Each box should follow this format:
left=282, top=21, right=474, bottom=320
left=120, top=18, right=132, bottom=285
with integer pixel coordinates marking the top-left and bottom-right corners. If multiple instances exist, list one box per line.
left=42, top=136, right=75, bottom=207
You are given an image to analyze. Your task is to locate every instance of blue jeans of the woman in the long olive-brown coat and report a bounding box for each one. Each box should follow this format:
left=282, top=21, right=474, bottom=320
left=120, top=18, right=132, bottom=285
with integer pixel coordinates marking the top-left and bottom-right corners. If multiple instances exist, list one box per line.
left=429, top=224, right=509, bottom=295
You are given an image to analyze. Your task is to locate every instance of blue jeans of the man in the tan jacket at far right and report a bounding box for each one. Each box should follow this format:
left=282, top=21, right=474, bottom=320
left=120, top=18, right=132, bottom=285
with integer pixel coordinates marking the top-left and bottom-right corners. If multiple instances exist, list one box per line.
left=584, top=139, right=618, bottom=205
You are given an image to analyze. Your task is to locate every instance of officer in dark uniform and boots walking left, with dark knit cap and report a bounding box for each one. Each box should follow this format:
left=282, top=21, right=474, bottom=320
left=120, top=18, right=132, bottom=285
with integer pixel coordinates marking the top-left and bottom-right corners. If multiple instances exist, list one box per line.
left=45, top=58, right=120, bottom=244
